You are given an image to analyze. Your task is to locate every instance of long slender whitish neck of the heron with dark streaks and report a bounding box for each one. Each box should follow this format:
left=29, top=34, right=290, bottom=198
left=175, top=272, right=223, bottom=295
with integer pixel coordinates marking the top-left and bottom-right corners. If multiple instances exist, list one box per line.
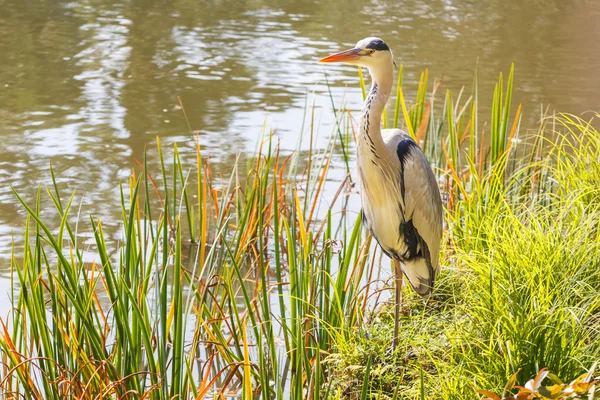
left=358, top=63, right=394, bottom=151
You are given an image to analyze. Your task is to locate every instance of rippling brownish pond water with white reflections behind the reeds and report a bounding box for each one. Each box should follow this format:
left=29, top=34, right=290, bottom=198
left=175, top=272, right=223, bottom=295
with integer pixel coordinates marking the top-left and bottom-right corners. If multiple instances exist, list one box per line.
left=0, top=0, right=600, bottom=315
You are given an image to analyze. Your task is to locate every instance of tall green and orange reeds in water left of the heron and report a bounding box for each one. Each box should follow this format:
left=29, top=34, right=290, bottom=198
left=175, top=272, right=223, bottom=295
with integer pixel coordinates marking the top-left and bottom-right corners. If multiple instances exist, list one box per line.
left=0, top=99, right=368, bottom=399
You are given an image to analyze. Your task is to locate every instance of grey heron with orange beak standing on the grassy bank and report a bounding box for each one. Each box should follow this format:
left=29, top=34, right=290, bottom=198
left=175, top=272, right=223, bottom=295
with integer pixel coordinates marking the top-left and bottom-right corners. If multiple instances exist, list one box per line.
left=319, top=37, right=442, bottom=349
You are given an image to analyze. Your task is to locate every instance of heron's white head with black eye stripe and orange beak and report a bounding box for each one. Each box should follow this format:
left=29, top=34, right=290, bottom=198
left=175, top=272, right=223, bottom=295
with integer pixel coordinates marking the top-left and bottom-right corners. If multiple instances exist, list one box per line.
left=319, top=37, right=394, bottom=69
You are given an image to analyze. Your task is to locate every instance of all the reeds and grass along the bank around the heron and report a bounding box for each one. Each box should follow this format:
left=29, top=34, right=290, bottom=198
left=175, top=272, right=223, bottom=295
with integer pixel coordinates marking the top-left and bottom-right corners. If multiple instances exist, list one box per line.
left=0, top=64, right=600, bottom=399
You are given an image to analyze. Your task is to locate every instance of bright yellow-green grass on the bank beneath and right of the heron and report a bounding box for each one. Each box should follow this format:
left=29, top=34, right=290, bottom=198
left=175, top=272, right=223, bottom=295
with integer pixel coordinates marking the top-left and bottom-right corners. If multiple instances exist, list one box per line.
left=327, top=116, right=600, bottom=399
